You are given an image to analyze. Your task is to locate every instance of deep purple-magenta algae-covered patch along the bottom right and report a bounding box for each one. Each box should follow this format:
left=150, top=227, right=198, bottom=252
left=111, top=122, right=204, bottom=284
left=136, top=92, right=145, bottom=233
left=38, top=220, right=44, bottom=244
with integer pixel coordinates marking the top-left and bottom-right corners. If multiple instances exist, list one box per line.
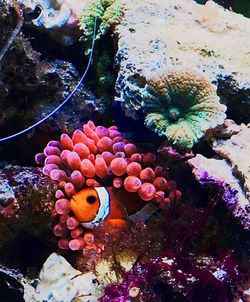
left=100, top=251, right=244, bottom=302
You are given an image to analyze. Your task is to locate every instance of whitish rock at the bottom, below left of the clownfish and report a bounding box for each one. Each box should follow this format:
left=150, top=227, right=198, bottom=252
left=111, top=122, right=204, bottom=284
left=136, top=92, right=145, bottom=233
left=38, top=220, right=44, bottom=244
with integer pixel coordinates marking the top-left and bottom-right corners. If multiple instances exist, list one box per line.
left=24, top=253, right=101, bottom=302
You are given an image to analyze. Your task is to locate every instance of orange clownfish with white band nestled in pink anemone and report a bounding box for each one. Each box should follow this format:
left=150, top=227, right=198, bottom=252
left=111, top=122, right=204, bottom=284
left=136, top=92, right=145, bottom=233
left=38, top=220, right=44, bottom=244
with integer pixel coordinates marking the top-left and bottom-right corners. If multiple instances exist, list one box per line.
left=70, top=187, right=145, bottom=229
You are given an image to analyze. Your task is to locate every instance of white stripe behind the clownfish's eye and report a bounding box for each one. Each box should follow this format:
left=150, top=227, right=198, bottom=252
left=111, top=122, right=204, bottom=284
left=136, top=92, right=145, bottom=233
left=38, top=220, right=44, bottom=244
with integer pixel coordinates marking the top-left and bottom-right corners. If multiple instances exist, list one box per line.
left=81, top=187, right=110, bottom=229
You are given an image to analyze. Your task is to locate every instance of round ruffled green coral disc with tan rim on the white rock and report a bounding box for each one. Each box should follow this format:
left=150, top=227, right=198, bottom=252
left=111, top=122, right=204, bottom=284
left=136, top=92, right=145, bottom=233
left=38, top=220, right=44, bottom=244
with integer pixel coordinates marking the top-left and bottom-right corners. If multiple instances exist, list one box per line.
left=142, top=70, right=226, bottom=148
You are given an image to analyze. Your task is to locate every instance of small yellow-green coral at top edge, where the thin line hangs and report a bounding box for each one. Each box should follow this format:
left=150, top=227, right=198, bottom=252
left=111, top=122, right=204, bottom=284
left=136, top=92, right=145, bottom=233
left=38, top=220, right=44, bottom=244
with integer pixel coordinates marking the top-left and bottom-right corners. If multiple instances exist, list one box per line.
left=79, top=0, right=123, bottom=54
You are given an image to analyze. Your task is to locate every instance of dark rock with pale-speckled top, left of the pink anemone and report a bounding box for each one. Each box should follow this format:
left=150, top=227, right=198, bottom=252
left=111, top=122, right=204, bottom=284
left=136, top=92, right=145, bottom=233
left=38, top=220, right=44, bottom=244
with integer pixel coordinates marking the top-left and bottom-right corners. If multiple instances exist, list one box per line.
left=0, top=166, right=56, bottom=270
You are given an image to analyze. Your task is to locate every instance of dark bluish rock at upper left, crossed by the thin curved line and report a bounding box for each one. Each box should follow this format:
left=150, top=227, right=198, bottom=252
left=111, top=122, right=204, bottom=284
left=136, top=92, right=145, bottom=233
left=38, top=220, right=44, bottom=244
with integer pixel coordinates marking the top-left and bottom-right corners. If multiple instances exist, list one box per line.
left=0, top=2, right=104, bottom=164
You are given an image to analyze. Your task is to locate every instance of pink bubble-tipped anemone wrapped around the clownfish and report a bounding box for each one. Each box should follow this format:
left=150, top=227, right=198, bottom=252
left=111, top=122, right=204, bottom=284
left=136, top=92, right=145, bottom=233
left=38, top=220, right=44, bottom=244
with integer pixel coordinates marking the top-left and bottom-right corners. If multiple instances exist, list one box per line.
left=36, top=121, right=181, bottom=250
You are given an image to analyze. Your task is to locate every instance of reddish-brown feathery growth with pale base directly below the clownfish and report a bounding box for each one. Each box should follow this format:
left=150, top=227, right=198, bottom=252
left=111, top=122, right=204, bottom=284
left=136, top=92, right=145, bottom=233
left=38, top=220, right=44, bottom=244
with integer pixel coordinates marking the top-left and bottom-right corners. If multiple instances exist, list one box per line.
left=76, top=215, right=168, bottom=285
